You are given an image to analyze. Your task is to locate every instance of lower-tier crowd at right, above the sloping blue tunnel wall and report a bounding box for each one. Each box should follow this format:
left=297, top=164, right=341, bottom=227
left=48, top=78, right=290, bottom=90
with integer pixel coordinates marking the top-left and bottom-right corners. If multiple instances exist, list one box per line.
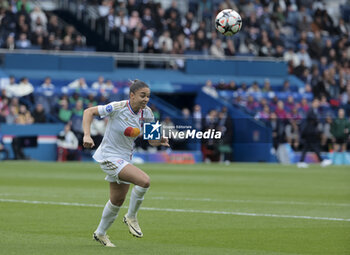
left=202, top=79, right=350, bottom=151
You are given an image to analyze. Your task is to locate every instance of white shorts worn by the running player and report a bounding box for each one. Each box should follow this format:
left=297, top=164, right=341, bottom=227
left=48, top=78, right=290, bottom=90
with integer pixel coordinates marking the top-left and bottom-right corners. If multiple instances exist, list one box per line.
left=99, top=158, right=130, bottom=184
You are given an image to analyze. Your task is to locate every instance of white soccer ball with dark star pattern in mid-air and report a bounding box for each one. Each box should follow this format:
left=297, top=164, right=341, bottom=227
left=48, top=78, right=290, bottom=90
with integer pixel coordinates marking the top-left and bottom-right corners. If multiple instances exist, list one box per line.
left=215, top=9, right=242, bottom=36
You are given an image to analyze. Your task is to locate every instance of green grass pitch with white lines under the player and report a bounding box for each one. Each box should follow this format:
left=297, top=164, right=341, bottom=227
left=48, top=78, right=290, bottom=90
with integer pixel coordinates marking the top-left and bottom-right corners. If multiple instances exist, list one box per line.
left=0, top=162, right=350, bottom=255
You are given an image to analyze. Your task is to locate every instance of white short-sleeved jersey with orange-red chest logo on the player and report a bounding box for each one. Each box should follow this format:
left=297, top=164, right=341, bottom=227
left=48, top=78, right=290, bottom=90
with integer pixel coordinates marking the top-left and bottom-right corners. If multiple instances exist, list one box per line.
left=93, top=100, right=154, bottom=162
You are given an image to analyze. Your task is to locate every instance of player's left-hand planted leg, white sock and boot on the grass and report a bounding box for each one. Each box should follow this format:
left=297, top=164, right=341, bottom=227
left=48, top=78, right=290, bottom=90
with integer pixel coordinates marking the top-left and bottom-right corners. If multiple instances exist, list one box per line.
left=94, top=182, right=130, bottom=247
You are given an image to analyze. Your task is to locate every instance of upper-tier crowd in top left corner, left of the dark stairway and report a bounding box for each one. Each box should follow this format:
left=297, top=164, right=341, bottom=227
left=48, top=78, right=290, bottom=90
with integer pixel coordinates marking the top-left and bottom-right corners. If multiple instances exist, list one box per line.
left=0, top=0, right=86, bottom=50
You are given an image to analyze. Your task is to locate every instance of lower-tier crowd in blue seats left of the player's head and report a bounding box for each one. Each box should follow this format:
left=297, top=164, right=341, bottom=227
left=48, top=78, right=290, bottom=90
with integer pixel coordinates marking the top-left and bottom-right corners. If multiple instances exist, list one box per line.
left=0, top=76, right=127, bottom=126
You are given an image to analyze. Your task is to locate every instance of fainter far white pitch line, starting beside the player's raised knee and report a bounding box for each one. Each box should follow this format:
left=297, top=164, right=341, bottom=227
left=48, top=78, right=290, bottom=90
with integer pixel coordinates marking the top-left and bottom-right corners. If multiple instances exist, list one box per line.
left=147, top=197, right=350, bottom=207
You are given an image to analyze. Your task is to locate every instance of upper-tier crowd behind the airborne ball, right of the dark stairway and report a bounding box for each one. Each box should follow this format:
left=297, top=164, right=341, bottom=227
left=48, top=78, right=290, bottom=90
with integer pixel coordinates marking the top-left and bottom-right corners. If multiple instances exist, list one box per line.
left=87, top=0, right=350, bottom=120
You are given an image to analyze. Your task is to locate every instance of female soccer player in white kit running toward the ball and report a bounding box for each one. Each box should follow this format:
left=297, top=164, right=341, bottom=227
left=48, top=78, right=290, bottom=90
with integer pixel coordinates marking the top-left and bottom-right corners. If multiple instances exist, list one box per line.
left=83, top=80, right=169, bottom=247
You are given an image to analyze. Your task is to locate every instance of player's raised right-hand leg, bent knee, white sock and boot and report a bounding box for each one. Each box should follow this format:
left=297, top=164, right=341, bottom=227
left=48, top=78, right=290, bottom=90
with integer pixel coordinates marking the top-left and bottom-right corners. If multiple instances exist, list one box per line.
left=118, top=164, right=150, bottom=237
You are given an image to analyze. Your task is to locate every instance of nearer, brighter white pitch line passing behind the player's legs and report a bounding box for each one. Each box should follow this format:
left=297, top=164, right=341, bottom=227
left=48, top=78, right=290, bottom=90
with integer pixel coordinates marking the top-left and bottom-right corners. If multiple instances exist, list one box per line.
left=0, top=198, right=350, bottom=222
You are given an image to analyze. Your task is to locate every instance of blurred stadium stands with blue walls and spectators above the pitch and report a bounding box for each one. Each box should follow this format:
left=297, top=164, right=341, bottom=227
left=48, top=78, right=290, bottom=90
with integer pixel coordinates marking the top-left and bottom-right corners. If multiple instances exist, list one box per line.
left=0, top=0, right=350, bottom=164
